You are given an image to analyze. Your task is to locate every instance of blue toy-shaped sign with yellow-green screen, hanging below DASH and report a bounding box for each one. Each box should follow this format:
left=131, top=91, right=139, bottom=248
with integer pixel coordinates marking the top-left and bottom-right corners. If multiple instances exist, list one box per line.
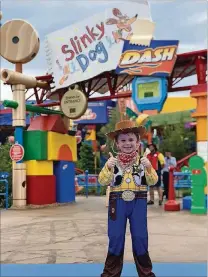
left=132, top=77, right=167, bottom=112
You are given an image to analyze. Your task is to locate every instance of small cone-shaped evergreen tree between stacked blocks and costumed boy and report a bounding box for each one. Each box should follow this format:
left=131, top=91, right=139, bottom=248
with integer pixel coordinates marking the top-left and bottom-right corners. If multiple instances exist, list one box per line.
left=77, top=143, right=95, bottom=174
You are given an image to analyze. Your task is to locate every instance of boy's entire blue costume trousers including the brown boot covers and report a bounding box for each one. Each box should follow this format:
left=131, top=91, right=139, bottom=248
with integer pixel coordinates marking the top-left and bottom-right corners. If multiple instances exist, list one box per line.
left=101, top=195, right=155, bottom=277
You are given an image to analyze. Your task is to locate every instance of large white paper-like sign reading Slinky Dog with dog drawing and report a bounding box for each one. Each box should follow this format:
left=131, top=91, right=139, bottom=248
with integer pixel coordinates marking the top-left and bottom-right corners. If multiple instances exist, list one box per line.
left=46, top=0, right=151, bottom=89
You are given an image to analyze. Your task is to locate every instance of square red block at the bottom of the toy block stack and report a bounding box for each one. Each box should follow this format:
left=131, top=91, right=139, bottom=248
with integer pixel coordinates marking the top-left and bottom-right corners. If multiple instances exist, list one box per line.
left=27, top=175, right=56, bottom=205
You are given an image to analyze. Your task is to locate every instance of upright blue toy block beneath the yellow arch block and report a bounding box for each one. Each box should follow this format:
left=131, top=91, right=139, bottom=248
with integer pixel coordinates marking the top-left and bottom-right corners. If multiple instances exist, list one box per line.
left=54, top=161, right=75, bottom=203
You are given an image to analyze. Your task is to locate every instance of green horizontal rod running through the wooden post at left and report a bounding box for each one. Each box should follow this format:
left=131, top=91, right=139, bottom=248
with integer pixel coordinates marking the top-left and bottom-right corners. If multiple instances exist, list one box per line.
left=3, top=100, right=64, bottom=115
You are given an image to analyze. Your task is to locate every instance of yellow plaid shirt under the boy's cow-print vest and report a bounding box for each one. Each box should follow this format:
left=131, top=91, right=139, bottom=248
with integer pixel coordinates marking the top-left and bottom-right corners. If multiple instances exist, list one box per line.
left=98, top=157, right=158, bottom=192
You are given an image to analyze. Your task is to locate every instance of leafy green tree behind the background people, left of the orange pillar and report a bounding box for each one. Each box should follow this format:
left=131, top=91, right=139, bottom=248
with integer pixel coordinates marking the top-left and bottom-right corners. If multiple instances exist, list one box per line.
left=160, top=123, right=196, bottom=160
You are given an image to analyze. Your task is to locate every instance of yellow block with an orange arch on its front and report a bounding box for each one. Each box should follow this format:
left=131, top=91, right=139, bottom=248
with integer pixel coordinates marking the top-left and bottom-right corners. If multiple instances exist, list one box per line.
left=48, top=132, right=77, bottom=162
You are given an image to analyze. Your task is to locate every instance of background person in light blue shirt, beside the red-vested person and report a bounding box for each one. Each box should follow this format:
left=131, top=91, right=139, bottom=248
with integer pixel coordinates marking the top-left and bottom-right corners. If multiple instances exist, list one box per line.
left=163, top=151, right=177, bottom=199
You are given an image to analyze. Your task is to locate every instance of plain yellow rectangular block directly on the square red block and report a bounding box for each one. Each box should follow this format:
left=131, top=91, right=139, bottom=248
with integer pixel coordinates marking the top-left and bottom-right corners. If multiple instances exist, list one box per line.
left=25, top=160, right=53, bottom=176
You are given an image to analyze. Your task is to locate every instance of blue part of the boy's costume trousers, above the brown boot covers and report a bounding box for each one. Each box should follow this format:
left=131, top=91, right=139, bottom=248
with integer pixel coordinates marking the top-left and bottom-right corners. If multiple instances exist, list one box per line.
left=108, top=198, right=148, bottom=255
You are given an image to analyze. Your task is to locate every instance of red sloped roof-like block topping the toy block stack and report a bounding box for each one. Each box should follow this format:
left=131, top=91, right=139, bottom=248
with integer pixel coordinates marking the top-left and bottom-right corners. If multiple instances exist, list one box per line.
left=27, top=115, right=68, bottom=134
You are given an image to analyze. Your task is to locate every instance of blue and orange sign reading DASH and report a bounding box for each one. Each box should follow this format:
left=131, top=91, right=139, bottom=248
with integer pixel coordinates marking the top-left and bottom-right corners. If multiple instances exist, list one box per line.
left=116, top=40, right=179, bottom=77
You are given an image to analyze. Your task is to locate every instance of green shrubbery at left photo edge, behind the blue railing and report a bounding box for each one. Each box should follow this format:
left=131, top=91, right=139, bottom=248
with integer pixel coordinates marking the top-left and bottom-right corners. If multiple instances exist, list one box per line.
left=0, top=144, right=12, bottom=208
